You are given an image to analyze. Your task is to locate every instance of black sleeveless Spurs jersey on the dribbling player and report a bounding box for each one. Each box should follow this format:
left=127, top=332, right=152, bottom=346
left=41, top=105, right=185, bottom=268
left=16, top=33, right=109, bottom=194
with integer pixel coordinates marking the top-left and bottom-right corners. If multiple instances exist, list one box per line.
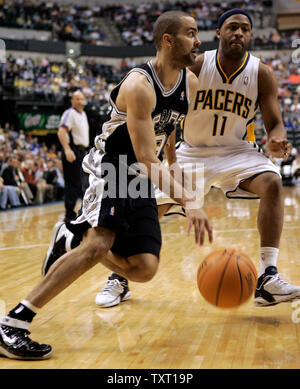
left=95, top=61, right=189, bottom=164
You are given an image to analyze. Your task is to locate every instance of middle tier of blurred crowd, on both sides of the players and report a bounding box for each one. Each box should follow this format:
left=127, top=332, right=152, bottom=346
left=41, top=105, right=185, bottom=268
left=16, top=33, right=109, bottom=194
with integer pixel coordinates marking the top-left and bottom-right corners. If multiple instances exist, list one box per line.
left=0, top=52, right=300, bottom=120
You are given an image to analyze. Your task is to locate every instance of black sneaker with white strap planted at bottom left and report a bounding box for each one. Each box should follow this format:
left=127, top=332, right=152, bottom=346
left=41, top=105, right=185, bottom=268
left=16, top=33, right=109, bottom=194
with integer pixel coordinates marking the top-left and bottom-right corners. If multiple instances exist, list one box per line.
left=0, top=316, right=53, bottom=360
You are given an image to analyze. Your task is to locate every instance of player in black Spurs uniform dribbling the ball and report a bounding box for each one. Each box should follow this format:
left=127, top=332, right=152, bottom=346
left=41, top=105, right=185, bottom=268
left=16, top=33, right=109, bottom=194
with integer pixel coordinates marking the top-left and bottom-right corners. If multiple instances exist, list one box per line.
left=0, top=11, right=212, bottom=359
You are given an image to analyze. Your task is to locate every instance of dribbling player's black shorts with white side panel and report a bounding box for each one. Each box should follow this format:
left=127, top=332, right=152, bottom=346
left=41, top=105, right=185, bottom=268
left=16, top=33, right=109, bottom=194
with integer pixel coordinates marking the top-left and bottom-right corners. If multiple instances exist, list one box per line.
left=67, top=152, right=162, bottom=258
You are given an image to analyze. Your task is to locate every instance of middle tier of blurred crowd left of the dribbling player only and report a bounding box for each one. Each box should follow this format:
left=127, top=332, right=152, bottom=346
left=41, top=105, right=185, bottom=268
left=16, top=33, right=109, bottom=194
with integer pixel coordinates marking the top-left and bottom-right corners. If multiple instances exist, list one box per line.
left=0, top=56, right=123, bottom=112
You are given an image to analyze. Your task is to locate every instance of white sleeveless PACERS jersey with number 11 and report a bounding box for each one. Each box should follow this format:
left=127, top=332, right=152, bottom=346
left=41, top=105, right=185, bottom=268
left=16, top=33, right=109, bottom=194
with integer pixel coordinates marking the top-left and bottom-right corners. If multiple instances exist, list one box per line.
left=183, top=50, right=259, bottom=147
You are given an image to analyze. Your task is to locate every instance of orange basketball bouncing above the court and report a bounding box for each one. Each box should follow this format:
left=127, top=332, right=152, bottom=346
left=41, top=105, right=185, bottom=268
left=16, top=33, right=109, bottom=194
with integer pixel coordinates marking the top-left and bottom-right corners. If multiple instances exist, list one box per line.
left=197, top=249, right=257, bottom=308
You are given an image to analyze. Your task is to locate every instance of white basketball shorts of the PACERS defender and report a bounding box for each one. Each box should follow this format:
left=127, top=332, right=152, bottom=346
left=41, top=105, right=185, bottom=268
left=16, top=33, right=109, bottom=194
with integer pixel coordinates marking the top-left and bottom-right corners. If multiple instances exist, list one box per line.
left=155, top=142, right=281, bottom=205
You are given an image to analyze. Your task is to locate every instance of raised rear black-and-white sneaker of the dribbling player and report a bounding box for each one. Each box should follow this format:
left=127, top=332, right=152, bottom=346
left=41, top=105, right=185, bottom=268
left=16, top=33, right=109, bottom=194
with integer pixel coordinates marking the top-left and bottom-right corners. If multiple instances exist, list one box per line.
left=42, top=222, right=67, bottom=277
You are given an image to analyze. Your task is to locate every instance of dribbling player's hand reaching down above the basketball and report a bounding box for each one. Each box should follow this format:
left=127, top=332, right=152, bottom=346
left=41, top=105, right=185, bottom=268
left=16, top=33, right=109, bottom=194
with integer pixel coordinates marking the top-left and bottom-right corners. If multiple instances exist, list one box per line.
left=185, top=209, right=213, bottom=246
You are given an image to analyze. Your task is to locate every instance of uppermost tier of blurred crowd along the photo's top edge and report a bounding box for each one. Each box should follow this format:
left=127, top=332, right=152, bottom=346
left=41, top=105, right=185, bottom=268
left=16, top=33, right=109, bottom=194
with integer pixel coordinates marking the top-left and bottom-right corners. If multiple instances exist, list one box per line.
left=0, top=0, right=299, bottom=48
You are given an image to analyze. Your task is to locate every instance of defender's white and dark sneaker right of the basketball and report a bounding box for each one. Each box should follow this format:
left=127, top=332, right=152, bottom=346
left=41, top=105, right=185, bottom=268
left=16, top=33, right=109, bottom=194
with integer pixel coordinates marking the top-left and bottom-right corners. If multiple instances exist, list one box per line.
left=254, top=266, right=300, bottom=307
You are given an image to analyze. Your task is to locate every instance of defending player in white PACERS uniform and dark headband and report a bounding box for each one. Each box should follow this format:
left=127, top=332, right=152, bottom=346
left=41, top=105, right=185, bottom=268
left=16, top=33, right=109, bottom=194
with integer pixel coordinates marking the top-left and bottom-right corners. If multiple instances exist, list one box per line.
left=96, top=9, right=300, bottom=307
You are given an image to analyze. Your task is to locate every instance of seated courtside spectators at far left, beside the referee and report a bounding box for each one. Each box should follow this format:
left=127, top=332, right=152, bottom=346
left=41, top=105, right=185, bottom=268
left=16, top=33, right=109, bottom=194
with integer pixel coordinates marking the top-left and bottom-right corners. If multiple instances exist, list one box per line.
left=0, top=123, right=64, bottom=210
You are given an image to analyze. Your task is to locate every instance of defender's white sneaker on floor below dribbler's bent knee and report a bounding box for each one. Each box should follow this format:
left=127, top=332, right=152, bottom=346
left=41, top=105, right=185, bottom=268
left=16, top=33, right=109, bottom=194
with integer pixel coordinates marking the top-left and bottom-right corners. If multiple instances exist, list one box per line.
left=95, top=273, right=131, bottom=308
